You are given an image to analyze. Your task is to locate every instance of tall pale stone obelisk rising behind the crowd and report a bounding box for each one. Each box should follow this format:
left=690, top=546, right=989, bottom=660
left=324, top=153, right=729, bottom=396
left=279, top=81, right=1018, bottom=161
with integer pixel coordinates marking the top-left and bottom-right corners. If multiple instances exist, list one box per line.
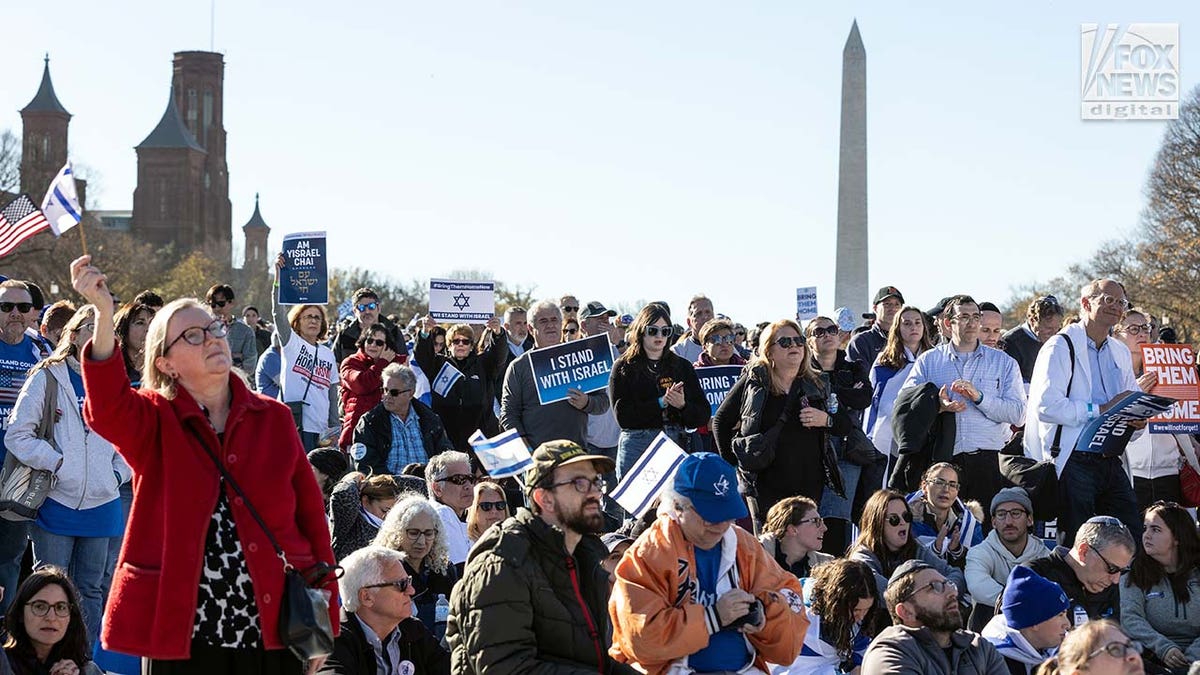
left=833, top=20, right=870, bottom=316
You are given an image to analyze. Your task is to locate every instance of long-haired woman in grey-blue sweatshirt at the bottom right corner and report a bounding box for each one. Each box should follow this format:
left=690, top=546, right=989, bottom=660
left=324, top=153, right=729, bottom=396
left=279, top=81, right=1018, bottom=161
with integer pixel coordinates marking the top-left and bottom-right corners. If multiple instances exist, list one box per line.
left=1121, top=502, right=1200, bottom=674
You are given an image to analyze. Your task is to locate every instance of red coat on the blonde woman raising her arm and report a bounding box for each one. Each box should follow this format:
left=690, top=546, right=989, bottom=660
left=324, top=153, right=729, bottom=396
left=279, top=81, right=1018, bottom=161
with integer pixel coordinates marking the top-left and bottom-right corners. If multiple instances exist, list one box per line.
left=82, top=344, right=340, bottom=659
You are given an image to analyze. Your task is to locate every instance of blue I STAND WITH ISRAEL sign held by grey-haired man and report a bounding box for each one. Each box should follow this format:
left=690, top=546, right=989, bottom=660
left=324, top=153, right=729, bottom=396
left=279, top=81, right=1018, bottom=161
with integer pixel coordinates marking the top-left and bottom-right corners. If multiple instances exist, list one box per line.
left=529, top=333, right=613, bottom=405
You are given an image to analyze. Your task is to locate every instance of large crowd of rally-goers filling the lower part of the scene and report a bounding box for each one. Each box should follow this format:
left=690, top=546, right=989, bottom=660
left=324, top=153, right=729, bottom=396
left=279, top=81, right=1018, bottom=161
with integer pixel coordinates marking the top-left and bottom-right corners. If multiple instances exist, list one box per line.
left=0, top=256, right=1200, bottom=675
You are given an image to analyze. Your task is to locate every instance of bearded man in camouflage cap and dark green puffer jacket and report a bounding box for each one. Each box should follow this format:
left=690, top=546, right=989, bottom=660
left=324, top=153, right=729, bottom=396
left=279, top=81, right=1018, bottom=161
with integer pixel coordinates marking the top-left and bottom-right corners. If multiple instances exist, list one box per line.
left=446, top=439, right=631, bottom=675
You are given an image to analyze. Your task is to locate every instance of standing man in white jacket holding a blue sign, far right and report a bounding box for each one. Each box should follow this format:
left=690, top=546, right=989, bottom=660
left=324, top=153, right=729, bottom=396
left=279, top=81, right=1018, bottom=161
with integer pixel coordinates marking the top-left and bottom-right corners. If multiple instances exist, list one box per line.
left=1025, top=279, right=1153, bottom=546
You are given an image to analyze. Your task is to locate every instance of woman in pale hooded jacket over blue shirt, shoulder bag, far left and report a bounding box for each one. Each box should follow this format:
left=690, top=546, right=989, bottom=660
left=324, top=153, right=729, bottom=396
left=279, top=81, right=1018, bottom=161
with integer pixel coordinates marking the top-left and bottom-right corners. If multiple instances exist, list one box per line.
left=5, top=305, right=133, bottom=644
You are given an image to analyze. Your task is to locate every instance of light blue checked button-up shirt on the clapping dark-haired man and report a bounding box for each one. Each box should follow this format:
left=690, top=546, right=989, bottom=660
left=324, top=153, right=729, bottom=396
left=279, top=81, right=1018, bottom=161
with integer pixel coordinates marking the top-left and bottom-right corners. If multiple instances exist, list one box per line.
left=901, top=342, right=1025, bottom=454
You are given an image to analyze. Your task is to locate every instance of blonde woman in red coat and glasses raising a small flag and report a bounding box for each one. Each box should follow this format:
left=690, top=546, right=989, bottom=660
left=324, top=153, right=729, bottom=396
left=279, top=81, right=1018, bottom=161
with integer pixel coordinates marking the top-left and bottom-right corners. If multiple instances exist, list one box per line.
left=71, top=256, right=338, bottom=675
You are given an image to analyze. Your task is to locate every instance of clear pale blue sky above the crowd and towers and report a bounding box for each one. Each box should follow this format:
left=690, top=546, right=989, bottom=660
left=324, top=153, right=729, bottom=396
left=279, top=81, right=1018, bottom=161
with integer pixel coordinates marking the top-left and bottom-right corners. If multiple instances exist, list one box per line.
left=0, top=0, right=1200, bottom=322
